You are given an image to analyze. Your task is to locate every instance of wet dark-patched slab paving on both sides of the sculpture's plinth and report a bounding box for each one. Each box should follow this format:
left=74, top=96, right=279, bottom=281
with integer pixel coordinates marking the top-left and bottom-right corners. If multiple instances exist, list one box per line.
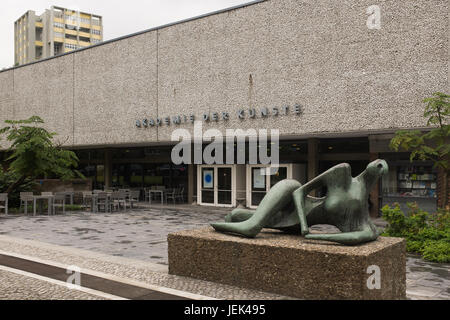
left=0, top=206, right=450, bottom=300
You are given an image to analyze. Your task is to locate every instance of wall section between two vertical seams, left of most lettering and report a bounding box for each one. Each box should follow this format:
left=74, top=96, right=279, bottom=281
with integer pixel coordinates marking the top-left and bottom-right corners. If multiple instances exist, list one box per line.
left=74, top=32, right=157, bottom=145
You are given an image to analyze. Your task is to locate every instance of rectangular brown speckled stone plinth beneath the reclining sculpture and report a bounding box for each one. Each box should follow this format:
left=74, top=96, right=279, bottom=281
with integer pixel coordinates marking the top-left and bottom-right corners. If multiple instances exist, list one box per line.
left=168, top=227, right=406, bottom=299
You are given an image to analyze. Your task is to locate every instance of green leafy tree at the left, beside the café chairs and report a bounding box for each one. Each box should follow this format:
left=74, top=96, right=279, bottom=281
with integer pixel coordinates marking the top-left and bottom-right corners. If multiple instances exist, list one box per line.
left=0, top=116, right=83, bottom=193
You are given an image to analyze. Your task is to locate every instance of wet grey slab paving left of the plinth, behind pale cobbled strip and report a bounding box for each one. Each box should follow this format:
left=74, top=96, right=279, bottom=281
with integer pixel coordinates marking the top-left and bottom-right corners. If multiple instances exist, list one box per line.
left=0, top=205, right=226, bottom=265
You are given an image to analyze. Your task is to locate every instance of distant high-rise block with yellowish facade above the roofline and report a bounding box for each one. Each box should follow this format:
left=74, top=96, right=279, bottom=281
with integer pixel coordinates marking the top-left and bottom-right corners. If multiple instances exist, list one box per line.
left=14, top=6, right=103, bottom=65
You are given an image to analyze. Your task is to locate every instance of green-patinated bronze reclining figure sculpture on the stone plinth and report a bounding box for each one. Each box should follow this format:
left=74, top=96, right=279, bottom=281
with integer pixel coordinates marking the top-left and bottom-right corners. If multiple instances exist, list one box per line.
left=212, top=160, right=389, bottom=245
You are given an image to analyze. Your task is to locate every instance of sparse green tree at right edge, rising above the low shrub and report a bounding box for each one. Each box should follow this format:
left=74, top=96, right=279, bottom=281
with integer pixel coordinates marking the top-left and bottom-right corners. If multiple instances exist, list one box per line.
left=390, top=92, right=450, bottom=207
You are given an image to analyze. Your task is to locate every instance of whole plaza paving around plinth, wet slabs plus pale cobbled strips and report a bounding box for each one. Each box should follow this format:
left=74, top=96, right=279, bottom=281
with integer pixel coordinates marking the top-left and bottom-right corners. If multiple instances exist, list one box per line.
left=0, top=204, right=450, bottom=300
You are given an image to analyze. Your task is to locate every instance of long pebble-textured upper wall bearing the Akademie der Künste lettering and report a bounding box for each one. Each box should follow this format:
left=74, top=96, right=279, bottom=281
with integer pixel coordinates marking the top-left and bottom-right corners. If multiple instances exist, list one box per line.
left=0, top=0, right=450, bottom=146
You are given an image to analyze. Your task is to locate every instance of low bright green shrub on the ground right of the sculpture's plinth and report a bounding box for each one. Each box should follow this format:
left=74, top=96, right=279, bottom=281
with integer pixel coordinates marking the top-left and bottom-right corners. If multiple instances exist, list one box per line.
left=382, top=203, right=450, bottom=262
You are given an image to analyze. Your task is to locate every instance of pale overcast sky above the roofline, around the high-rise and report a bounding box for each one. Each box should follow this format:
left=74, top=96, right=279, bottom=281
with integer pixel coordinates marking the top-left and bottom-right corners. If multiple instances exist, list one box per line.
left=0, top=0, right=250, bottom=69
